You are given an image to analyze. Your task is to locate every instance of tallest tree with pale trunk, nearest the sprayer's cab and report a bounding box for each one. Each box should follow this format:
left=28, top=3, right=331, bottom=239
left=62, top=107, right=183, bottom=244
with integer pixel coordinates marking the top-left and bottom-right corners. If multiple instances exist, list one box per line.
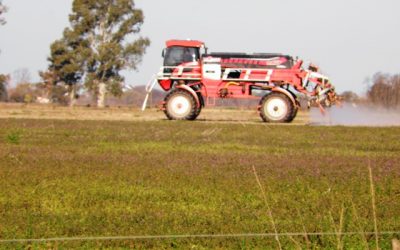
left=64, top=0, right=150, bottom=107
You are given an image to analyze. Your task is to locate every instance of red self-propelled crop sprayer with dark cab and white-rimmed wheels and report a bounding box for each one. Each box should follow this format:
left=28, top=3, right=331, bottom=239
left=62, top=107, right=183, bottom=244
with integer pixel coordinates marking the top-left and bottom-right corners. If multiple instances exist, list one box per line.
left=143, top=40, right=337, bottom=122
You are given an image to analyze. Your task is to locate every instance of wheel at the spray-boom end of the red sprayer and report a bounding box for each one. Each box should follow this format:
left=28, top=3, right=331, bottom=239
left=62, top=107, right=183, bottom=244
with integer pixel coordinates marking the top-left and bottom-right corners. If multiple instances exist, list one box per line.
left=260, top=92, right=297, bottom=123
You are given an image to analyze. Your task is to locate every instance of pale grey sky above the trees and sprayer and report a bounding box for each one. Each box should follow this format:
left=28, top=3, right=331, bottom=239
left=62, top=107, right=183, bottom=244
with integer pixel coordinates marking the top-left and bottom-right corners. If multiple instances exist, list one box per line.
left=0, top=0, right=400, bottom=94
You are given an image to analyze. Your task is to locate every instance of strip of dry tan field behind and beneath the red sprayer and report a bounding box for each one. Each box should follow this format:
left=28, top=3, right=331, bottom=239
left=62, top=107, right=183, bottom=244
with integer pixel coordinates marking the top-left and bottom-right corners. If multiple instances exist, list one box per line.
left=0, top=103, right=310, bottom=125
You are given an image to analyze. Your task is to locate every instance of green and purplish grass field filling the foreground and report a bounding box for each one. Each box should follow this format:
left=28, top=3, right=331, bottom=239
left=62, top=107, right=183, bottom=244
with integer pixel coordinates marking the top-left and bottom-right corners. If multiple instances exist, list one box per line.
left=0, top=119, right=400, bottom=249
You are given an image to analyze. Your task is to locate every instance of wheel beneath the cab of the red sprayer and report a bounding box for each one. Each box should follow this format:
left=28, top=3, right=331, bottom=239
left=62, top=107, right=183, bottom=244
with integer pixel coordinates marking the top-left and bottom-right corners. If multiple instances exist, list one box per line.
left=164, top=89, right=201, bottom=120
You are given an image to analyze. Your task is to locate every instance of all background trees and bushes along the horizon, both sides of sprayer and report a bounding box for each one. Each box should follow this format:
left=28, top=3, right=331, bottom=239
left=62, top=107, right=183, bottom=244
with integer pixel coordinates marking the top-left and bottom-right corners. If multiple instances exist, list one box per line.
left=0, top=0, right=400, bottom=107
